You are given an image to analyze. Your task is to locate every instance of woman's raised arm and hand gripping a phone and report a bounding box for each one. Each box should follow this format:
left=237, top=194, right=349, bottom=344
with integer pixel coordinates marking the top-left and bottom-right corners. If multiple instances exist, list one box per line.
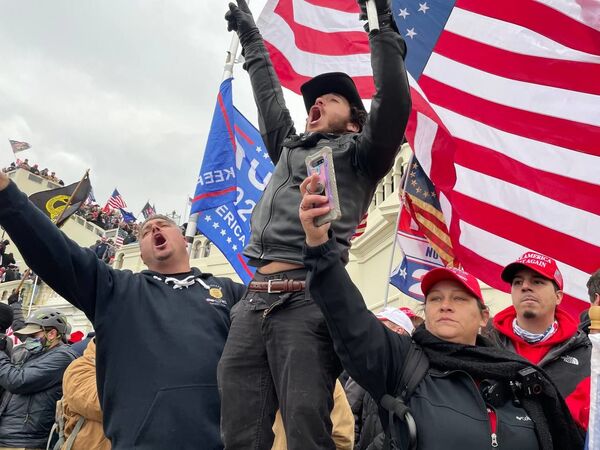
left=300, top=176, right=410, bottom=400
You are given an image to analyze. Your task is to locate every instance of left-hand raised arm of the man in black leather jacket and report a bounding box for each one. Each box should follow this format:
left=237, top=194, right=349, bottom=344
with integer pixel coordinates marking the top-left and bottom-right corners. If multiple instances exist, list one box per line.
left=225, top=0, right=296, bottom=164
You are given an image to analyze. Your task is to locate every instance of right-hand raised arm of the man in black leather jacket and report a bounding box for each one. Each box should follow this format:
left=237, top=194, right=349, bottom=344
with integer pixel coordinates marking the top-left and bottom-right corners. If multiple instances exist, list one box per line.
left=357, top=0, right=411, bottom=179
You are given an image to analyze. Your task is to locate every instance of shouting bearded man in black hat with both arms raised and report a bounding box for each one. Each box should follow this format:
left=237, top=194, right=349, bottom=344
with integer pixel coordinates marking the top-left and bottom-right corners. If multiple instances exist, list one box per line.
left=218, top=0, right=411, bottom=450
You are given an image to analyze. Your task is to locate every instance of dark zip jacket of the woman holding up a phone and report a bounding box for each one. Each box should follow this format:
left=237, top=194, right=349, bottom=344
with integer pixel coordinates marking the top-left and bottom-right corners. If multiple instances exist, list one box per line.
left=304, top=239, right=539, bottom=450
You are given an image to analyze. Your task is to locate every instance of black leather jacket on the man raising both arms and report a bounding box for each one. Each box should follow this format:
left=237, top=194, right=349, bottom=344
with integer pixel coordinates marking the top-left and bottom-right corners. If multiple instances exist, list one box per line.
left=244, top=22, right=411, bottom=265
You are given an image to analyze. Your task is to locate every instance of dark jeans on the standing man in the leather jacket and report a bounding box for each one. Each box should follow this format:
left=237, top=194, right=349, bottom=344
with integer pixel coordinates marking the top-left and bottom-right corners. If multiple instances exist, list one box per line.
left=217, top=271, right=341, bottom=450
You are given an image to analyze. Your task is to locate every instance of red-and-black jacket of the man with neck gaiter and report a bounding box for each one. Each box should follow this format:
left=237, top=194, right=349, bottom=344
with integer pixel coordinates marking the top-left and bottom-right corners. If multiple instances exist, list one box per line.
left=489, top=306, right=592, bottom=430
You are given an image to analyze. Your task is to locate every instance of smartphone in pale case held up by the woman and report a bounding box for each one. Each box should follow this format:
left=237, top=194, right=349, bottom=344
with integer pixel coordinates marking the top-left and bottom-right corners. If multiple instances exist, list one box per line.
left=306, top=147, right=342, bottom=227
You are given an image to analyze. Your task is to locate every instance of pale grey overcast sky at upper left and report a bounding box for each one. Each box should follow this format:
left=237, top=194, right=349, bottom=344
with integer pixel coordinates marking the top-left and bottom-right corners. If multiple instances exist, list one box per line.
left=0, top=0, right=305, bottom=222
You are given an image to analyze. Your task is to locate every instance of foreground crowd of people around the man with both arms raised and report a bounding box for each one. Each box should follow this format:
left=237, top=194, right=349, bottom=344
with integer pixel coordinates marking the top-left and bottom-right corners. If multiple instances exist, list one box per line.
left=0, top=0, right=600, bottom=450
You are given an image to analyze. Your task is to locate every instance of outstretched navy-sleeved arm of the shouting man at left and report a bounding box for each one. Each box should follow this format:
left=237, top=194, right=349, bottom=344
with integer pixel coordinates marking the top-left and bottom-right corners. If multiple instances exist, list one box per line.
left=0, top=173, right=113, bottom=321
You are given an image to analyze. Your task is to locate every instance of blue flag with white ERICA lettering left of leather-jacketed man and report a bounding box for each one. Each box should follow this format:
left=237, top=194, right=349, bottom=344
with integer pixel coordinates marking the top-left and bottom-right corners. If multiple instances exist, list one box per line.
left=191, top=78, right=273, bottom=283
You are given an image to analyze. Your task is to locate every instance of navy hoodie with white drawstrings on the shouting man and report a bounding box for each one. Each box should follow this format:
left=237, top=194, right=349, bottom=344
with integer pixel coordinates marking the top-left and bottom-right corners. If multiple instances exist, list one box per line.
left=0, top=182, right=244, bottom=450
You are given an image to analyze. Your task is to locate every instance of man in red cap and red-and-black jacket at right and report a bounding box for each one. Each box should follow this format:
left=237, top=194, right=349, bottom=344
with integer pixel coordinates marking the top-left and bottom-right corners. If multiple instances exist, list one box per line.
left=490, top=252, right=592, bottom=429
